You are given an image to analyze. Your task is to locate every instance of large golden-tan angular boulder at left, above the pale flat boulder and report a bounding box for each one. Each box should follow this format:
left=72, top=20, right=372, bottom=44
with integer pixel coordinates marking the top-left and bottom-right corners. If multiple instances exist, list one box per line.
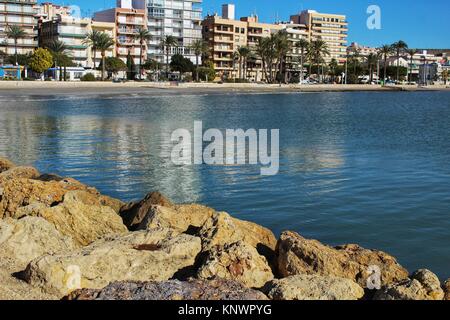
left=15, top=191, right=128, bottom=246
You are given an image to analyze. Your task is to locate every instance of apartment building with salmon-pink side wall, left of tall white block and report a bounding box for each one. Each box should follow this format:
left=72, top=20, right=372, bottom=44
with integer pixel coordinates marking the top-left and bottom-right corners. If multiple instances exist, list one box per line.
left=93, top=0, right=147, bottom=64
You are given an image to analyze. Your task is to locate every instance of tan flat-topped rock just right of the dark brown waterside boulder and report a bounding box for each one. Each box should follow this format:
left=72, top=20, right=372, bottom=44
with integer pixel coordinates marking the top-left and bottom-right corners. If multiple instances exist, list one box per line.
left=136, top=204, right=215, bottom=232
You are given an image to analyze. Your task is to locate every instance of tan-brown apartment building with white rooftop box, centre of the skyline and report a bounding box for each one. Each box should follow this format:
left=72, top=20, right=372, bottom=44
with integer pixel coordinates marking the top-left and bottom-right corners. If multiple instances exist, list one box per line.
left=202, top=5, right=283, bottom=81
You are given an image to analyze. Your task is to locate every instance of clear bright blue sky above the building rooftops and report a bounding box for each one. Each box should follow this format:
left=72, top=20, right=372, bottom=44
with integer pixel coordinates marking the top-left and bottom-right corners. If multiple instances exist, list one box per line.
left=41, top=0, right=450, bottom=49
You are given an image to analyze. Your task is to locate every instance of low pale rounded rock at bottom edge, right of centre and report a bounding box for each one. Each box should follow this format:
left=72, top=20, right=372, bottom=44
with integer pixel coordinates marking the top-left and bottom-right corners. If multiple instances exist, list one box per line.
left=264, top=274, right=364, bottom=300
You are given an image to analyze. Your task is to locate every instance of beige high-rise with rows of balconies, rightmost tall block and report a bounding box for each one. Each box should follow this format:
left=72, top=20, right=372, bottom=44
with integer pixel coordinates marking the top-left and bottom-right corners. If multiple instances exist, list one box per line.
left=290, top=10, right=348, bottom=64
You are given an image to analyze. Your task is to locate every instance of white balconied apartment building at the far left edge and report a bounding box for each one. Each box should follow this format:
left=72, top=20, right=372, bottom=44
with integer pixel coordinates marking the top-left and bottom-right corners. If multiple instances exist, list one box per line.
left=0, top=0, right=37, bottom=55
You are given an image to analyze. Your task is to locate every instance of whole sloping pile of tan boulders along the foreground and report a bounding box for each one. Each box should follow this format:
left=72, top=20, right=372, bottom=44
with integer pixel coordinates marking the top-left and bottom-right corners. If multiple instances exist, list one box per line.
left=0, top=158, right=450, bottom=300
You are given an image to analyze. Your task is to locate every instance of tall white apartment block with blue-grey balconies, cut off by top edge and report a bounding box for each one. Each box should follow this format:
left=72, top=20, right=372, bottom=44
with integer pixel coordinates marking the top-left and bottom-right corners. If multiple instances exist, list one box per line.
left=146, top=0, right=202, bottom=63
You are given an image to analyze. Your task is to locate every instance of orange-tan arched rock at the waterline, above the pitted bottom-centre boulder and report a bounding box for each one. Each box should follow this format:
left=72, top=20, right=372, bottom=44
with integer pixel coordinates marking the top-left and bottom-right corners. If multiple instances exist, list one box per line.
left=199, top=212, right=277, bottom=256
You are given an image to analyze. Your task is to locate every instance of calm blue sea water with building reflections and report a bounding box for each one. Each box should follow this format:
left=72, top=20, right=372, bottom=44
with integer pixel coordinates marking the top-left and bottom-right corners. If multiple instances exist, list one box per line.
left=0, top=92, right=450, bottom=278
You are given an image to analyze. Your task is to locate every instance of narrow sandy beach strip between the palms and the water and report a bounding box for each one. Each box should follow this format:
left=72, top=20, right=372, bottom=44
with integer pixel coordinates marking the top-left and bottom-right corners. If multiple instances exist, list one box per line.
left=0, top=81, right=450, bottom=97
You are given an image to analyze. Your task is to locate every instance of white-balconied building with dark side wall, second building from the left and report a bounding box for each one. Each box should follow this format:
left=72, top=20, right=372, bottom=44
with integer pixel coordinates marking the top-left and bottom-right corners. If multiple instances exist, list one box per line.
left=39, top=14, right=91, bottom=68
